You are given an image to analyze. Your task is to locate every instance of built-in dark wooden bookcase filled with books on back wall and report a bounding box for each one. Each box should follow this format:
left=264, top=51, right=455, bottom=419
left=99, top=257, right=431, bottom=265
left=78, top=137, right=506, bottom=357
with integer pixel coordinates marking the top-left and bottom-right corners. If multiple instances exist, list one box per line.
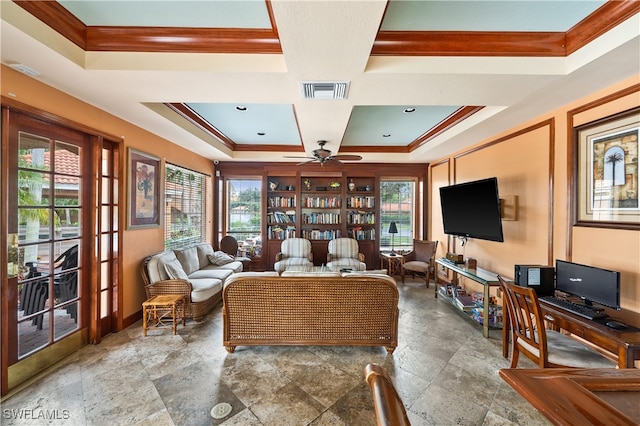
left=216, top=162, right=427, bottom=270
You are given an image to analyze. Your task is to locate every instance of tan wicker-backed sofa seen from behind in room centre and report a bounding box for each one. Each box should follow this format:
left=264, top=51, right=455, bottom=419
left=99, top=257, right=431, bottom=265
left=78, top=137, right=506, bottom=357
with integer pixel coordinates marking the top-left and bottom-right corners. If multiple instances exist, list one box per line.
left=222, top=272, right=398, bottom=353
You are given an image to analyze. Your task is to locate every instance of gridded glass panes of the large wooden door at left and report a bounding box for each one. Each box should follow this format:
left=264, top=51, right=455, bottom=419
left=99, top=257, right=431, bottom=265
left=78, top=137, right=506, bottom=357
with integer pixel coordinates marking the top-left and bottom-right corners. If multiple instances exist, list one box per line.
left=15, top=131, right=83, bottom=359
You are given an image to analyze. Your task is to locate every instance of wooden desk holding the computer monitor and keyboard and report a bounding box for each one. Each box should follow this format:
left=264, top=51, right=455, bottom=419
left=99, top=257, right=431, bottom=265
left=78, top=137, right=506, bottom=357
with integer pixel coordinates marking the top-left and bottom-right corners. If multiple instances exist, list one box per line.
left=502, top=300, right=640, bottom=368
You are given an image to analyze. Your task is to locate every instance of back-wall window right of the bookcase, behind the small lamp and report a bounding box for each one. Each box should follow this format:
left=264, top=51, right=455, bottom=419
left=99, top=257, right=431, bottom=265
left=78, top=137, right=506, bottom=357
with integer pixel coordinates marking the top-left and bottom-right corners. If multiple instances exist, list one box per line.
left=380, top=179, right=415, bottom=251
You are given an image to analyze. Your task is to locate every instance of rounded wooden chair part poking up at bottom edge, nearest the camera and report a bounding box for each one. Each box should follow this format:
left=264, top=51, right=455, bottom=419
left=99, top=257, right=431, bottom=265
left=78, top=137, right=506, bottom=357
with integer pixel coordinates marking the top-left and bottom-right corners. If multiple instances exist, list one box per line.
left=364, top=364, right=411, bottom=426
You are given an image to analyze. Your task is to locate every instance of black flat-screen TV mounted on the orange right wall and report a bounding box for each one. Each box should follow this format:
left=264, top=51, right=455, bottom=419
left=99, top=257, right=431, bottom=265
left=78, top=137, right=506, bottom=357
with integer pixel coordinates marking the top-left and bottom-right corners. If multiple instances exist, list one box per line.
left=440, top=177, right=504, bottom=242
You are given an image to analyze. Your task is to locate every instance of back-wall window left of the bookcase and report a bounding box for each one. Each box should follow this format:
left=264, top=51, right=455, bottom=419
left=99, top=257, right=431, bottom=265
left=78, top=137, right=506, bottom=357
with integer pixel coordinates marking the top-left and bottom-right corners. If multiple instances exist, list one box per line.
left=226, top=178, right=262, bottom=255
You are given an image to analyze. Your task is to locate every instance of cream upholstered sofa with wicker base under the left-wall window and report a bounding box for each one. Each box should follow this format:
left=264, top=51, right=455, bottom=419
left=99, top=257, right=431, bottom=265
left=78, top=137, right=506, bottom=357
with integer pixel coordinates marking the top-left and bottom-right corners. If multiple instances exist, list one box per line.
left=141, top=243, right=242, bottom=321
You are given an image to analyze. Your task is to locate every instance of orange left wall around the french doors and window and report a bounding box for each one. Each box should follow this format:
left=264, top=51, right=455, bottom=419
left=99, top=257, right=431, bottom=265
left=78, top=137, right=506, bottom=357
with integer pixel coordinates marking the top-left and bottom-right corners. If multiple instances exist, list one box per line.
left=0, top=65, right=218, bottom=318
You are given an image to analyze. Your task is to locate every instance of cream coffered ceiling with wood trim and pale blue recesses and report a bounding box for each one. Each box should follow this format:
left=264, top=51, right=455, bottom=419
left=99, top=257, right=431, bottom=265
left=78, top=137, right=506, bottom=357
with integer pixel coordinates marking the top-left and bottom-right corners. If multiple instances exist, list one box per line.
left=1, top=0, right=640, bottom=162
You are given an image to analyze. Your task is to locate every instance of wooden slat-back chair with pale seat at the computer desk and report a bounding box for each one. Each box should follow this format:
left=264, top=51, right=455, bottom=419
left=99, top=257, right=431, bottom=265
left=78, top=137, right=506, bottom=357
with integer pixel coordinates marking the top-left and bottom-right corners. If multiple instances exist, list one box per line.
left=498, top=276, right=615, bottom=368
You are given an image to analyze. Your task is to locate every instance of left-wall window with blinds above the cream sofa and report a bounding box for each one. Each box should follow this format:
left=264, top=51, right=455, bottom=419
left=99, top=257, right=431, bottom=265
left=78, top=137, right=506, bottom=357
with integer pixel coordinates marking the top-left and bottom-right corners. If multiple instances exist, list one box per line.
left=164, top=163, right=206, bottom=250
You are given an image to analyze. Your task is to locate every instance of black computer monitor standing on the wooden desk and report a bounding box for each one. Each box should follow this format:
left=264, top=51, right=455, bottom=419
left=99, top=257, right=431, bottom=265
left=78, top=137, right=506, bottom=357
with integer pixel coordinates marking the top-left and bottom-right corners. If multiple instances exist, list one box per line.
left=556, top=260, right=620, bottom=310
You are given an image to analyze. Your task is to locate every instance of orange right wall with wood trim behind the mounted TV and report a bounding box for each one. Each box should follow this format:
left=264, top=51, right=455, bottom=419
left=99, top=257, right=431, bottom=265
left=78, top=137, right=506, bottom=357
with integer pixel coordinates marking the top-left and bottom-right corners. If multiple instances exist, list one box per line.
left=429, top=76, right=640, bottom=312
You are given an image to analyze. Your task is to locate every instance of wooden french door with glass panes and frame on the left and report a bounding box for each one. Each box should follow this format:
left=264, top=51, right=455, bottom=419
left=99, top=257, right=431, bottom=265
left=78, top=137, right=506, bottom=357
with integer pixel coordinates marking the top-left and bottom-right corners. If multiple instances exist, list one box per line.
left=1, top=109, right=120, bottom=394
